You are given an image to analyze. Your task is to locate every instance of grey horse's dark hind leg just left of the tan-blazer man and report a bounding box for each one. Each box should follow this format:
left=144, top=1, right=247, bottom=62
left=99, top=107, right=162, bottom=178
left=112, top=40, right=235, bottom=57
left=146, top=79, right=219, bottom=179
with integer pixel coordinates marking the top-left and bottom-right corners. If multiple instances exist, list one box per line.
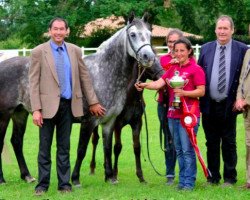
left=11, top=107, right=35, bottom=183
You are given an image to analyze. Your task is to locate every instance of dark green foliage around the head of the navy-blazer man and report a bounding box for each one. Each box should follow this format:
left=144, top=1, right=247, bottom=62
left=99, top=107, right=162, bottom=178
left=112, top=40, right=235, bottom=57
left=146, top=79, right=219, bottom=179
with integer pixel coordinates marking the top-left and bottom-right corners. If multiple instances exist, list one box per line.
left=172, top=0, right=250, bottom=41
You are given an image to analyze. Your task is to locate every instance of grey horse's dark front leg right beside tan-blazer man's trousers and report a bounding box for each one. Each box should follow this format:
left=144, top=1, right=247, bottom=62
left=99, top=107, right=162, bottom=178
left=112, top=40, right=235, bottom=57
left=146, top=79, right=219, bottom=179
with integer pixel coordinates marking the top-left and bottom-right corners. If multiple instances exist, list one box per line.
left=71, top=122, right=94, bottom=187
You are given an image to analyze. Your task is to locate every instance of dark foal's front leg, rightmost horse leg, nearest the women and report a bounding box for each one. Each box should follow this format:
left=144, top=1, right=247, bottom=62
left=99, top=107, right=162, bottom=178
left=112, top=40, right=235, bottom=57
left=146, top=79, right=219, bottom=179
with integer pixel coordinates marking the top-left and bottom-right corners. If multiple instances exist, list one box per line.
left=131, top=119, right=146, bottom=183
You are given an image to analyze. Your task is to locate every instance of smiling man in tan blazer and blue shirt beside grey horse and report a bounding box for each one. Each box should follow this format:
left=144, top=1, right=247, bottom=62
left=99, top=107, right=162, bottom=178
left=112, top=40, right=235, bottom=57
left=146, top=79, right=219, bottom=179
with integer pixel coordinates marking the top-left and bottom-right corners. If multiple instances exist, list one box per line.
left=29, top=18, right=105, bottom=195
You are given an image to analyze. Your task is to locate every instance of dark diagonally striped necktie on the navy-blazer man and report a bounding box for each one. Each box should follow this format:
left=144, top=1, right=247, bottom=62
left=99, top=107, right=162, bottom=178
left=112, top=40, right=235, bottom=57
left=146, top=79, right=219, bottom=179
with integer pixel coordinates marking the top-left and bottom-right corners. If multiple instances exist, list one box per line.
left=218, top=46, right=226, bottom=93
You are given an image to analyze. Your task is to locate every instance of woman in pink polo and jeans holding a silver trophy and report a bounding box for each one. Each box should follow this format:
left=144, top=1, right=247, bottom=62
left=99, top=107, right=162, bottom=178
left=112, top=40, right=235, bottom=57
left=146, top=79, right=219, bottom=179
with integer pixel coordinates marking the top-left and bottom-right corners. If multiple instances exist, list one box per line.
left=135, top=38, right=205, bottom=190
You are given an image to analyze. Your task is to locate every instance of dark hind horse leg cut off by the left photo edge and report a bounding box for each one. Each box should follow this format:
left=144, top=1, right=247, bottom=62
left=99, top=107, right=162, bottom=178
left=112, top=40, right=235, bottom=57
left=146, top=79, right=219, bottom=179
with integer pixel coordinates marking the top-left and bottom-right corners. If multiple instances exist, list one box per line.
left=0, top=113, right=10, bottom=184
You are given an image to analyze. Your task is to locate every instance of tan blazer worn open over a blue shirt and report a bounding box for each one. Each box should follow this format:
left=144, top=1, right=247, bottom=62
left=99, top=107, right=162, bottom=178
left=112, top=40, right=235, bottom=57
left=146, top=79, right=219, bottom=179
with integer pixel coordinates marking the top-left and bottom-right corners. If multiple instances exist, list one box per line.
left=29, top=41, right=98, bottom=118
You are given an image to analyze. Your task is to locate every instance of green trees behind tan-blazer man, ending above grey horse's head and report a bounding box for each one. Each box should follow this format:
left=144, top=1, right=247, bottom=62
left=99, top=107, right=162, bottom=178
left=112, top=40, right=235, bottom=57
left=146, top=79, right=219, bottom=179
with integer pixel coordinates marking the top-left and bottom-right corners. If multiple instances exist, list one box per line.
left=1, top=0, right=166, bottom=47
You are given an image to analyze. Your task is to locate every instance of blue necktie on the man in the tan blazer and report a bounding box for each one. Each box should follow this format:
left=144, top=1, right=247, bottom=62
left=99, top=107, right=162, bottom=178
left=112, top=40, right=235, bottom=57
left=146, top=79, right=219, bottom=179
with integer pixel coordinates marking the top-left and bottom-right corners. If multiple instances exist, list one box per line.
left=56, top=47, right=66, bottom=94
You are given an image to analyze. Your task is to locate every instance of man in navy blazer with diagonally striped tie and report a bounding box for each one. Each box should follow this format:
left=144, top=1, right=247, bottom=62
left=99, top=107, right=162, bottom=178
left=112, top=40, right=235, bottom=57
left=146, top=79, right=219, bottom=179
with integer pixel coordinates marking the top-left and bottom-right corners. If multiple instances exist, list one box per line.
left=198, top=15, right=248, bottom=186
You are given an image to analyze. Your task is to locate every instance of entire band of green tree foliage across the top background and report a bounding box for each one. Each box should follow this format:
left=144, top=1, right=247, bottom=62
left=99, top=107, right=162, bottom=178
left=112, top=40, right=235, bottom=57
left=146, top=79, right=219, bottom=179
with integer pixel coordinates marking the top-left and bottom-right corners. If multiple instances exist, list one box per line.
left=0, top=0, right=250, bottom=47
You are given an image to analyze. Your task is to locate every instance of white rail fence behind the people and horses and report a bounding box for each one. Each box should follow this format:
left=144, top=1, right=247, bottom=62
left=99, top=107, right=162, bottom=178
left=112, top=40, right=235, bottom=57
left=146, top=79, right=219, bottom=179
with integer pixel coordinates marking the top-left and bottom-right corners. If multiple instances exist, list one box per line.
left=0, top=44, right=250, bottom=62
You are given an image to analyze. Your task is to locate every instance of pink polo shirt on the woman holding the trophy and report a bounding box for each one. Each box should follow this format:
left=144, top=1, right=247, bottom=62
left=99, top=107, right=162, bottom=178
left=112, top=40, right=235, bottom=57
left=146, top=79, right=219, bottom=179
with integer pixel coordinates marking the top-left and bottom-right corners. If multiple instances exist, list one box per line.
left=161, top=58, right=205, bottom=118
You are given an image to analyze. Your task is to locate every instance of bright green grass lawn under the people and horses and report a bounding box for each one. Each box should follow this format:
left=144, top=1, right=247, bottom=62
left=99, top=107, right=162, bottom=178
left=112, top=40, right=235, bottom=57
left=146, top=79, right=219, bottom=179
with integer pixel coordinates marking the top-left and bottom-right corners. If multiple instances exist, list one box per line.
left=0, top=91, right=250, bottom=200
